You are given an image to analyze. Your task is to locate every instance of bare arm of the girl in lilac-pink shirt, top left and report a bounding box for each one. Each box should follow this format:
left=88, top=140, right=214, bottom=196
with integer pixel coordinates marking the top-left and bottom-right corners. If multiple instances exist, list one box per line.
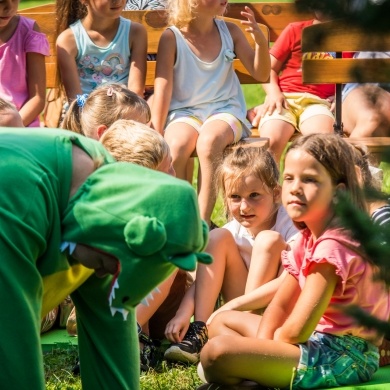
left=19, top=53, right=46, bottom=126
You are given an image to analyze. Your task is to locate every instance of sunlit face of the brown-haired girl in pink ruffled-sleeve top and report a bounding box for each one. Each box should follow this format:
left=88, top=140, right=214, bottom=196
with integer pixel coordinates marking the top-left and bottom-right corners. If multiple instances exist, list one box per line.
left=282, top=149, right=336, bottom=234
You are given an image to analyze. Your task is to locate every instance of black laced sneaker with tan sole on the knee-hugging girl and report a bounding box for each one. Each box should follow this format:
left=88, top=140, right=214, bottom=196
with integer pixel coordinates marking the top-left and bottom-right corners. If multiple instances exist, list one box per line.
left=164, top=321, right=208, bottom=364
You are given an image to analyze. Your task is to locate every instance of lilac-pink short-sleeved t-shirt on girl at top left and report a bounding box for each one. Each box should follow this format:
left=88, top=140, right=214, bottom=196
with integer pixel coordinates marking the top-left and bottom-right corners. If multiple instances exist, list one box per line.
left=0, top=16, right=49, bottom=127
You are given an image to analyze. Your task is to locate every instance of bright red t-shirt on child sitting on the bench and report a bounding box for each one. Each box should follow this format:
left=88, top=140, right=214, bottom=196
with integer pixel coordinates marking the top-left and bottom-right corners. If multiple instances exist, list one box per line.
left=270, top=20, right=335, bottom=99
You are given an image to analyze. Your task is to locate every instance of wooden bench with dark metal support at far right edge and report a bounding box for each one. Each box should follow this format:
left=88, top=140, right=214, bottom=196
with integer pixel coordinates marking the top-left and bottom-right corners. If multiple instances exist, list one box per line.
left=302, top=20, right=390, bottom=163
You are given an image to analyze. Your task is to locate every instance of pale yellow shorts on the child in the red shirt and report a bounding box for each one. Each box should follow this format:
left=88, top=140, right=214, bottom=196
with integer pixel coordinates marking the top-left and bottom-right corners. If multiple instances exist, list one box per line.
left=259, top=92, right=334, bottom=131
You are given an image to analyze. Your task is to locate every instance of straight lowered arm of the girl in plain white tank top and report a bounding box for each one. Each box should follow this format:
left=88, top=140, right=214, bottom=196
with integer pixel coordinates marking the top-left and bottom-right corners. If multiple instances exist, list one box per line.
left=151, top=29, right=176, bottom=134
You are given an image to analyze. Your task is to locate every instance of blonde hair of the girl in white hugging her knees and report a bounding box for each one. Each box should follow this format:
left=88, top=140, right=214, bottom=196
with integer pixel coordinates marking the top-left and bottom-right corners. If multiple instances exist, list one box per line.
left=217, top=146, right=279, bottom=217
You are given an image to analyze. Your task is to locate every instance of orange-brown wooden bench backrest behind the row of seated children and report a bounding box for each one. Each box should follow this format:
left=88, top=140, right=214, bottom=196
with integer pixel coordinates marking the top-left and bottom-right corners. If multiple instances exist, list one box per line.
left=19, top=3, right=311, bottom=88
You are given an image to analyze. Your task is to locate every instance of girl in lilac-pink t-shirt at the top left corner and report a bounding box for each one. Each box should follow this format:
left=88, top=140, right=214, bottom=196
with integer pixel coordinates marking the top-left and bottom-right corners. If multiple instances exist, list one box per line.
left=0, top=0, right=49, bottom=127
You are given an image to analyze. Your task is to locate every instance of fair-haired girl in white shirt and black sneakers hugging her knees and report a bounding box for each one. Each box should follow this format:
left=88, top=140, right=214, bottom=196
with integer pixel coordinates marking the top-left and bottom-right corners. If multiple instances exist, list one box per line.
left=165, top=147, right=297, bottom=363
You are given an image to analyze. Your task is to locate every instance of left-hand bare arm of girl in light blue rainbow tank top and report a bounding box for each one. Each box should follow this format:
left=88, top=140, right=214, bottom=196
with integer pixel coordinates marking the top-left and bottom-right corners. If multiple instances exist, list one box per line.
left=56, top=28, right=82, bottom=102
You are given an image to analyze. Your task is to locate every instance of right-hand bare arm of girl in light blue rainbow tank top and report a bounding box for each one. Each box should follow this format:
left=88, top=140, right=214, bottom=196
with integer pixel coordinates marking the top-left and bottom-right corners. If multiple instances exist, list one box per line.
left=128, top=22, right=148, bottom=97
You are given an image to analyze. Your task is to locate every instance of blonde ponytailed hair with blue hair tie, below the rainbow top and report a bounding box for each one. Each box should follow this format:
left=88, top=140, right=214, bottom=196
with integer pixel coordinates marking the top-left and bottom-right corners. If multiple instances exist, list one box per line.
left=61, top=83, right=150, bottom=139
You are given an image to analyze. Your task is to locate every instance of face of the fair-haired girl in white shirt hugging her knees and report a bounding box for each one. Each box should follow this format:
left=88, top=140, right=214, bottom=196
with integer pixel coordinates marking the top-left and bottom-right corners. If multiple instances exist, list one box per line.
left=226, top=175, right=279, bottom=236
